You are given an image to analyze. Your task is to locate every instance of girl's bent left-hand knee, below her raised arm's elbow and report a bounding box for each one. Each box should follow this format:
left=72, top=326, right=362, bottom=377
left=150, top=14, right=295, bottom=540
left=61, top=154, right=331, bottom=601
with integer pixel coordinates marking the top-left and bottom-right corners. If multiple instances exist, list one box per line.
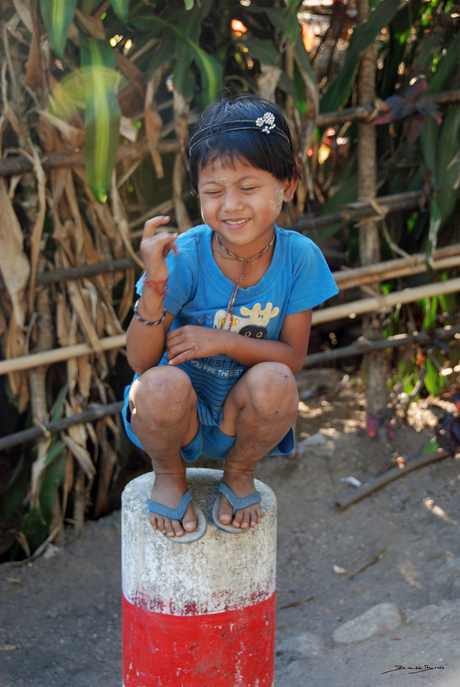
left=129, top=365, right=196, bottom=426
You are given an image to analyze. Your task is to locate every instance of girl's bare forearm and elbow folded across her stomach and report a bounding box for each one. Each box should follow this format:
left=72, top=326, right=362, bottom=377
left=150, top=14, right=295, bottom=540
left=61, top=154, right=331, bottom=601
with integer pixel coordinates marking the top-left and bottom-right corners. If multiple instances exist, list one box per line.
left=166, top=309, right=312, bottom=374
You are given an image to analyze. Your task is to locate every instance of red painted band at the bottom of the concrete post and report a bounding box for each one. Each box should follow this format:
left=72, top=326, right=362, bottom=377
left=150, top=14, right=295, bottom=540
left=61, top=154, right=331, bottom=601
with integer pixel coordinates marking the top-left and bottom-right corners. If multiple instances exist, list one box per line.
left=123, top=594, right=276, bottom=687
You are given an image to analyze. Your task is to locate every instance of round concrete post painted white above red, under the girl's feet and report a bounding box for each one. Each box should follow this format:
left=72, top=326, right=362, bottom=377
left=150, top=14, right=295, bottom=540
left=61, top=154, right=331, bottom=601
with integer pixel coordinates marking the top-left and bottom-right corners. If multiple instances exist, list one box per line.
left=122, top=468, right=276, bottom=687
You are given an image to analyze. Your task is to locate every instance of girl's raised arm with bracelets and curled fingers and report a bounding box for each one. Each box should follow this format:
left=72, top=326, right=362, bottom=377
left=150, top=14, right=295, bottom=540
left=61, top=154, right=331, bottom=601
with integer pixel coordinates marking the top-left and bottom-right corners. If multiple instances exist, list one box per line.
left=126, top=216, right=177, bottom=375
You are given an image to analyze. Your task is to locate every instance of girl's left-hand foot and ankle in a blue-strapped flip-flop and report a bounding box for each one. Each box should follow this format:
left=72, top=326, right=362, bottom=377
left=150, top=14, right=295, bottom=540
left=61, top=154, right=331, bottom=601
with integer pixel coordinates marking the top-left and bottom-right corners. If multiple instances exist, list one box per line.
left=150, top=474, right=197, bottom=537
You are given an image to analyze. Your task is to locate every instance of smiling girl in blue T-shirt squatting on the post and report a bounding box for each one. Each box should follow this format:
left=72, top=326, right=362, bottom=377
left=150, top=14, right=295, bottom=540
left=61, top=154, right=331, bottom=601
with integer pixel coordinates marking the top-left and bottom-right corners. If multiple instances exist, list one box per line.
left=123, top=96, right=337, bottom=543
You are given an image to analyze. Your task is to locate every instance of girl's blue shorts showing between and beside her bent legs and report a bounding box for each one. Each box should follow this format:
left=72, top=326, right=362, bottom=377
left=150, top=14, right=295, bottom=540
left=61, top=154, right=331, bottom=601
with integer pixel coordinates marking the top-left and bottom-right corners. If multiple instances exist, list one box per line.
left=121, top=386, right=295, bottom=463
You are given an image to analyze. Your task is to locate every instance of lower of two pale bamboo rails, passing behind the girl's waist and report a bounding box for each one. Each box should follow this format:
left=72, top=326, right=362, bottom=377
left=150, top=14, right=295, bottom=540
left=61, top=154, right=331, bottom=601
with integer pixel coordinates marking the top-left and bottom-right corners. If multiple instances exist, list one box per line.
left=0, top=278, right=460, bottom=375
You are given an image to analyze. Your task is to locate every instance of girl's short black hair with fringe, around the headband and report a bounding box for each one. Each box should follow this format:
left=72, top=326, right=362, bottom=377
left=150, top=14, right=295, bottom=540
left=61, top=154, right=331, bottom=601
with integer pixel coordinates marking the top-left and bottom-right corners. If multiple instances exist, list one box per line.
left=190, top=94, right=299, bottom=193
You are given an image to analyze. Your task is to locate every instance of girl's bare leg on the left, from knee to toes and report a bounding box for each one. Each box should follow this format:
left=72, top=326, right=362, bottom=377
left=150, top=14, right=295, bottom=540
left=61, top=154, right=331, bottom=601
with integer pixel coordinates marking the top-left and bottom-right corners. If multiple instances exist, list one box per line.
left=129, top=365, right=199, bottom=537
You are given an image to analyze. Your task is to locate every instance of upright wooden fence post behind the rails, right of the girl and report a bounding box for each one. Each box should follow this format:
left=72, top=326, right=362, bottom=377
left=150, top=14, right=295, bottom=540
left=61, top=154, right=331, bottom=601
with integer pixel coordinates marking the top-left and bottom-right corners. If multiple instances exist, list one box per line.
left=357, top=0, right=387, bottom=416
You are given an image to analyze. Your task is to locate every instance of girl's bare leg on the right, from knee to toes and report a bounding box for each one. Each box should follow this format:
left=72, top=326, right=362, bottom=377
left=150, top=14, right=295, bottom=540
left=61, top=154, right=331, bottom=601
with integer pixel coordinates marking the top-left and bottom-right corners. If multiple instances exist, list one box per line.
left=219, top=363, right=299, bottom=529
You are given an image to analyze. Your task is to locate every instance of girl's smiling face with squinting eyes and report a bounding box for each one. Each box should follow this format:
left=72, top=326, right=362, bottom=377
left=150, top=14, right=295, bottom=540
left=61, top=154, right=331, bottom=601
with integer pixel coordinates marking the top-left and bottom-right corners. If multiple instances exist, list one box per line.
left=198, top=157, right=297, bottom=258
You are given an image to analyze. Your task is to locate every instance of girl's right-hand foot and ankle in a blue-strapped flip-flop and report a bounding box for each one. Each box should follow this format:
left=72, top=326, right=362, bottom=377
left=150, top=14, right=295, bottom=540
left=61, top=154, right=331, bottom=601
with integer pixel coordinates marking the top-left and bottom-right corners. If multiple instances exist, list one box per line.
left=219, top=467, right=262, bottom=530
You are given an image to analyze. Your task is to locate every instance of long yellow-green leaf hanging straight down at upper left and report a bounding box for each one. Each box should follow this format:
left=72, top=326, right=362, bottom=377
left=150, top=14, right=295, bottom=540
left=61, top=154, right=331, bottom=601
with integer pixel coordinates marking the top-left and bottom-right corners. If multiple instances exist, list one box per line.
left=80, top=37, right=120, bottom=203
